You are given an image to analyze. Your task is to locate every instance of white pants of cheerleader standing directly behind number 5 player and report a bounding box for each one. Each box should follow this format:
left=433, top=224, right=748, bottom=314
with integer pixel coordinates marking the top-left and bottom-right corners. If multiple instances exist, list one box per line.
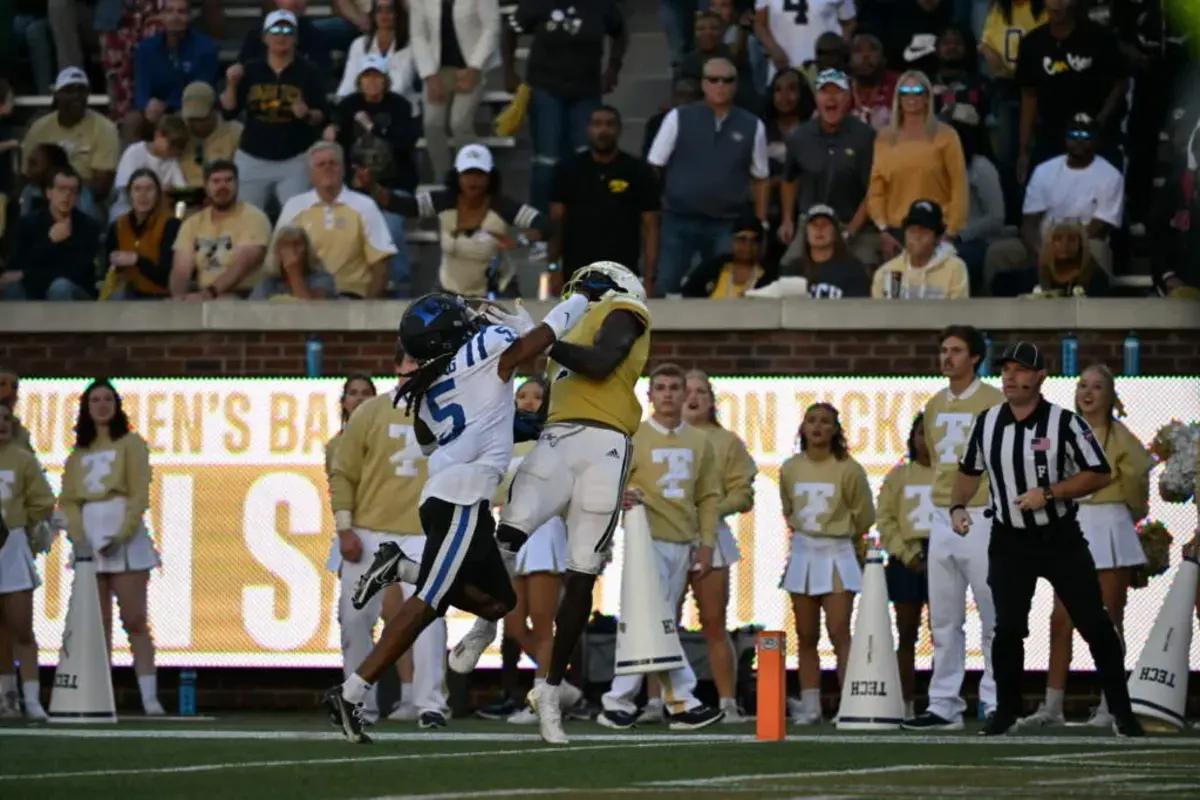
left=337, top=528, right=450, bottom=718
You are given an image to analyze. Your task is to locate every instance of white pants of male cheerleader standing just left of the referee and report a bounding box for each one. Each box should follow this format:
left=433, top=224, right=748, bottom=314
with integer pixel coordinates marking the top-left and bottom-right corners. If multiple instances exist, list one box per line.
left=928, top=506, right=996, bottom=721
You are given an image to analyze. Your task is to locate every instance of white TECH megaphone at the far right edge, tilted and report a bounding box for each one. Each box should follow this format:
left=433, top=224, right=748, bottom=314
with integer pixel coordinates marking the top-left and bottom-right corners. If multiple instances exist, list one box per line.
left=1129, top=558, right=1200, bottom=733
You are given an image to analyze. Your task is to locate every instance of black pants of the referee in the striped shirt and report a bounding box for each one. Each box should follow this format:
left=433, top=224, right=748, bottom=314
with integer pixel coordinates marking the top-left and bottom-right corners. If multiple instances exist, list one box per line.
left=988, top=519, right=1132, bottom=717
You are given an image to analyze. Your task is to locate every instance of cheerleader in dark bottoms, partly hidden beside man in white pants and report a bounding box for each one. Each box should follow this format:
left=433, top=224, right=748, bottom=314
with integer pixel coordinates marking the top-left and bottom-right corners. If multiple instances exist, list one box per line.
left=876, top=414, right=935, bottom=720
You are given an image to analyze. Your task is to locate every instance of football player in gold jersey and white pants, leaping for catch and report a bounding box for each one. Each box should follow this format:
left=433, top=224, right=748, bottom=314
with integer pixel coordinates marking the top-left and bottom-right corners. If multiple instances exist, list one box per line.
left=496, top=261, right=650, bottom=744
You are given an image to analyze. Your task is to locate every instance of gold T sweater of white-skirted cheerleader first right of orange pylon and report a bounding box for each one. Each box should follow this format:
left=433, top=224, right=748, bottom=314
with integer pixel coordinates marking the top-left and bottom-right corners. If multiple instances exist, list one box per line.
left=779, top=453, right=875, bottom=539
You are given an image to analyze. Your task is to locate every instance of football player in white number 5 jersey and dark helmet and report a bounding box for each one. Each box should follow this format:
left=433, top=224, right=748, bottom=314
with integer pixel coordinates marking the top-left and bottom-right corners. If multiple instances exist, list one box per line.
left=325, top=294, right=587, bottom=744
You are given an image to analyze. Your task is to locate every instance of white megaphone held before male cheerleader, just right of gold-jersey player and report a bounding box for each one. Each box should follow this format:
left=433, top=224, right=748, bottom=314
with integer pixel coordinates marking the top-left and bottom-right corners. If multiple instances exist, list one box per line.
left=613, top=505, right=685, bottom=675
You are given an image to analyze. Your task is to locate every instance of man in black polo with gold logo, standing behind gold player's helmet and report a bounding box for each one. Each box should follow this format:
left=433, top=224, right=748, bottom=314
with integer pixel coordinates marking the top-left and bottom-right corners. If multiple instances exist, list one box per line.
left=550, top=106, right=659, bottom=295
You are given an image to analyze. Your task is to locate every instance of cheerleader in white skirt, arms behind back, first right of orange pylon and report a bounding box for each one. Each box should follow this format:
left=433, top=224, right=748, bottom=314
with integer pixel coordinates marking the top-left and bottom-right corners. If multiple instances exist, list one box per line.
left=779, top=403, right=875, bottom=724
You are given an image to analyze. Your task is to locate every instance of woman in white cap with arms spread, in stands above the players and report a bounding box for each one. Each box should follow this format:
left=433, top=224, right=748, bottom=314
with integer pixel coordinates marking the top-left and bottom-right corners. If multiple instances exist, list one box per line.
left=376, top=144, right=550, bottom=296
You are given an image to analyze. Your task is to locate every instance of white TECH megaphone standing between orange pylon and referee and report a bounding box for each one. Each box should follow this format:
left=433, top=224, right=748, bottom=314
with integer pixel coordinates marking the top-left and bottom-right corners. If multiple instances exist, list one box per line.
left=838, top=551, right=904, bottom=730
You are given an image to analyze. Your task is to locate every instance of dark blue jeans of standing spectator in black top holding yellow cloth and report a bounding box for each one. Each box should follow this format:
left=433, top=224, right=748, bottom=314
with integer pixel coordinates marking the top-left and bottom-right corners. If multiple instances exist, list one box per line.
left=529, top=89, right=600, bottom=213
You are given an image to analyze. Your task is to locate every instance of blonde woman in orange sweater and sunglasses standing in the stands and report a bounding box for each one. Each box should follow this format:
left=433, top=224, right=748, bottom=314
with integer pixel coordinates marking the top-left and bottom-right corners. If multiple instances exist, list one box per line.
left=866, top=72, right=970, bottom=258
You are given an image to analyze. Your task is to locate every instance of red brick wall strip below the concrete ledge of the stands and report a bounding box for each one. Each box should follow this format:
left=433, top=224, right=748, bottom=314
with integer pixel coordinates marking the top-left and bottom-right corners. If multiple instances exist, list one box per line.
left=0, top=330, right=1200, bottom=378
